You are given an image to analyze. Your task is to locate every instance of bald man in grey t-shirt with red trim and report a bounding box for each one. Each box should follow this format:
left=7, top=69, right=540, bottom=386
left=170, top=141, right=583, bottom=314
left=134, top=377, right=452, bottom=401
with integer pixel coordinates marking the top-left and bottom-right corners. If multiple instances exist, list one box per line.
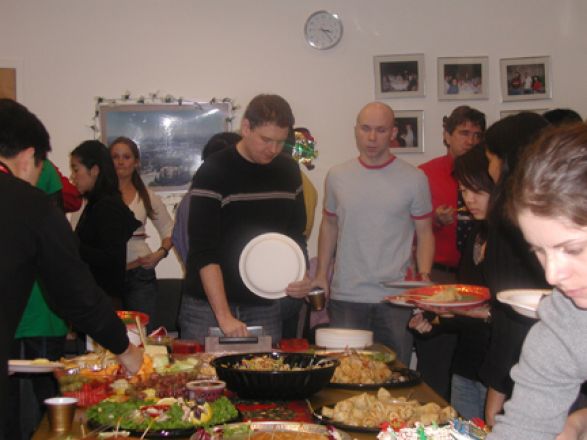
left=314, top=102, right=434, bottom=364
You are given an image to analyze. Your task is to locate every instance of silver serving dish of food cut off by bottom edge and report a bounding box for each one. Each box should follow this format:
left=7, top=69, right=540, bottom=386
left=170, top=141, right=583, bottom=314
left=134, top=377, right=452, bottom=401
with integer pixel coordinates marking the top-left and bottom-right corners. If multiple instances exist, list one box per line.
left=198, top=422, right=351, bottom=440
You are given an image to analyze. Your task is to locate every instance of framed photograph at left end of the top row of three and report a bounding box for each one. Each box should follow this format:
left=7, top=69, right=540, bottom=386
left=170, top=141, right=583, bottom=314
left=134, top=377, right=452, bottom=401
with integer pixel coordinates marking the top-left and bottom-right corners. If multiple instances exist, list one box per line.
left=373, top=54, right=424, bottom=99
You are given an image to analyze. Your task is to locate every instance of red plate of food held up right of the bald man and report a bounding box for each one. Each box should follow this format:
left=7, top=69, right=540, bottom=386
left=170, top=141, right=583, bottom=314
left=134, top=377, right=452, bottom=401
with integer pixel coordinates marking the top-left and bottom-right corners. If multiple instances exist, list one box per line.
left=385, top=284, right=491, bottom=308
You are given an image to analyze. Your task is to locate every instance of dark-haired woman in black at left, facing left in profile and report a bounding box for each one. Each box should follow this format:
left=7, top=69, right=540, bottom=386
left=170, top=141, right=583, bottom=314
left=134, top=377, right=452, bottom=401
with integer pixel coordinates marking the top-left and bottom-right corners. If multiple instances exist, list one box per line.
left=70, top=140, right=140, bottom=307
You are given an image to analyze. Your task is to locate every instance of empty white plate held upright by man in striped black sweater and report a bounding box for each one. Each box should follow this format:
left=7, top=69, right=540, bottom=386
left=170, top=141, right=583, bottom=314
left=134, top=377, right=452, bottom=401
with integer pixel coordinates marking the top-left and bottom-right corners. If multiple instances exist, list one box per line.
left=239, top=232, right=306, bottom=299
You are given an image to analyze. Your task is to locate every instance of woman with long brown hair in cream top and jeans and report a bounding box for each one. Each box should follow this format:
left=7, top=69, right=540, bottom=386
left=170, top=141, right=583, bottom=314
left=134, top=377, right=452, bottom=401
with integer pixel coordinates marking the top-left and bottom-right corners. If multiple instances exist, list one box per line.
left=109, top=137, right=173, bottom=326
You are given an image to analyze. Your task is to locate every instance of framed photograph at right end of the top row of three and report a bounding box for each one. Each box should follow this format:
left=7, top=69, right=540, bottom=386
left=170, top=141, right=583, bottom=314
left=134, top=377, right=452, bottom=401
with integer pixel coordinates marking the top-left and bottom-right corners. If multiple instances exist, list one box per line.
left=499, top=56, right=552, bottom=101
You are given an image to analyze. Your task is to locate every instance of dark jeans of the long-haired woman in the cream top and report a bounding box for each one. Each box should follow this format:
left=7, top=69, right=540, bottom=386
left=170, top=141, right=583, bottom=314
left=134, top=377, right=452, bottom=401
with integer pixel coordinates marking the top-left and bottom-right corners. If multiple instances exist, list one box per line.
left=122, top=267, right=158, bottom=331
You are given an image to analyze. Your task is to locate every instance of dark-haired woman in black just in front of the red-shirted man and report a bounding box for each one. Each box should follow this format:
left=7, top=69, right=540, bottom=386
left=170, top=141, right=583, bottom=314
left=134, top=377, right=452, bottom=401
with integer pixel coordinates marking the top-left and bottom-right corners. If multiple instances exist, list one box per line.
left=410, top=146, right=494, bottom=419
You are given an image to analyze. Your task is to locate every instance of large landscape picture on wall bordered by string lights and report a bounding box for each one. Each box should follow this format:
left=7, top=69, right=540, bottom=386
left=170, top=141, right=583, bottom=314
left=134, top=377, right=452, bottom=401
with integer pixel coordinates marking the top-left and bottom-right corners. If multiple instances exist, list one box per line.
left=99, top=101, right=232, bottom=192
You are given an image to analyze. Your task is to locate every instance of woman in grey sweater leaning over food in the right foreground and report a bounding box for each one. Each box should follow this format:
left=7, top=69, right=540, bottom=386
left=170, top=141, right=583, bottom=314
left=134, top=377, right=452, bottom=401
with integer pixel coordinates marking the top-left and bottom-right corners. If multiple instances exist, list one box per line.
left=488, top=124, right=587, bottom=440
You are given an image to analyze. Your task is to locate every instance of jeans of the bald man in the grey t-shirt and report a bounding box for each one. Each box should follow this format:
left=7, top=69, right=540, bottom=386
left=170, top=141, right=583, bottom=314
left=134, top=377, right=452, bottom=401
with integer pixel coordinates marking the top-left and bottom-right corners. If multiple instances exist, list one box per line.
left=329, top=300, right=413, bottom=365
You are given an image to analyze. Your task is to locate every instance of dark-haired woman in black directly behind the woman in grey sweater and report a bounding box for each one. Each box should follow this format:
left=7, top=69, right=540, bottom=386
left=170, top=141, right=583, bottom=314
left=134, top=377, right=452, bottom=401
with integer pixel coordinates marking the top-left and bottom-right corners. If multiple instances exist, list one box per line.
left=481, top=112, right=548, bottom=425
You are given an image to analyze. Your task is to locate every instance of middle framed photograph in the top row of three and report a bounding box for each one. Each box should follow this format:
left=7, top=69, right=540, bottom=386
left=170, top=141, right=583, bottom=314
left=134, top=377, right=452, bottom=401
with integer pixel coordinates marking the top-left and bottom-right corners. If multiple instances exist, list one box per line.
left=438, top=57, right=489, bottom=101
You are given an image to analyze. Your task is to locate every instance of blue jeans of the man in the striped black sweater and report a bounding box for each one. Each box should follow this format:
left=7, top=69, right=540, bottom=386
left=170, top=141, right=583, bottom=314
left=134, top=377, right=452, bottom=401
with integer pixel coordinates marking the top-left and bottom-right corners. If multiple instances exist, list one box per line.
left=179, top=295, right=281, bottom=345
